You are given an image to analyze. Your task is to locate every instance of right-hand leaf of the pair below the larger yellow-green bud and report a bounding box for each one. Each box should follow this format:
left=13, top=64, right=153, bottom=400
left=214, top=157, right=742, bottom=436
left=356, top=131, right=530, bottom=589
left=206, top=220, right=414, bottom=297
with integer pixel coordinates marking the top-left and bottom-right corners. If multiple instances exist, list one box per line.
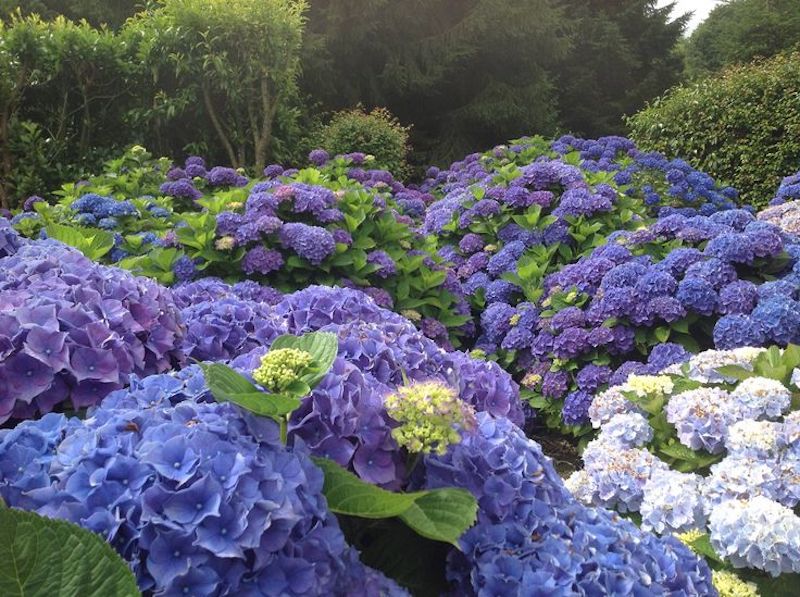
left=400, top=488, right=478, bottom=547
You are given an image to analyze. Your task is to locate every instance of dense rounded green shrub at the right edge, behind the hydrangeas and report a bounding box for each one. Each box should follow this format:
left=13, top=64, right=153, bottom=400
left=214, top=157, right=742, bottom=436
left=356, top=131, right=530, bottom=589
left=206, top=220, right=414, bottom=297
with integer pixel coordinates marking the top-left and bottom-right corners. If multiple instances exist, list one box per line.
left=628, top=52, right=800, bottom=207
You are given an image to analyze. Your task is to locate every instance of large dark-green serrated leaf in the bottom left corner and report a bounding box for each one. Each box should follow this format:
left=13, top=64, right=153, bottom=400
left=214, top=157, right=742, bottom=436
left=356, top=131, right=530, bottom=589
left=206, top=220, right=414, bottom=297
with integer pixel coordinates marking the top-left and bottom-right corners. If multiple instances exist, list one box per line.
left=0, top=507, right=140, bottom=597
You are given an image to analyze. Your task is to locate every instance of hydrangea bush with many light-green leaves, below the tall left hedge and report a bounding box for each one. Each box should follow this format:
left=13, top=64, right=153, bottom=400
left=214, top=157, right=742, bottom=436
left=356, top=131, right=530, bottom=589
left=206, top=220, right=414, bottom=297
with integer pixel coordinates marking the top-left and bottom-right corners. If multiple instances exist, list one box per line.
left=13, top=148, right=474, bottom=347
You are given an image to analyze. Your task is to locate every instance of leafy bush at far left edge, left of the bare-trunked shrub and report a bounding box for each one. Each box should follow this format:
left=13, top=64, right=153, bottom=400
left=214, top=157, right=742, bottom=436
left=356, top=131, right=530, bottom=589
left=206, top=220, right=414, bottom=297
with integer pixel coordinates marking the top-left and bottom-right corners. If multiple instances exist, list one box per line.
left=0, top=16, right=136, bottom=207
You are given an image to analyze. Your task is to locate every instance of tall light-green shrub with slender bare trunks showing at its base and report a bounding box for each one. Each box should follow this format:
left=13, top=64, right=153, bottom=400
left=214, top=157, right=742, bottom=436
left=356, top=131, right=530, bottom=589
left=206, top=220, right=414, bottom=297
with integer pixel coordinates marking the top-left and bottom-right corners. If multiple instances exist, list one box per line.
left=131, top=0, right=306, bottom=171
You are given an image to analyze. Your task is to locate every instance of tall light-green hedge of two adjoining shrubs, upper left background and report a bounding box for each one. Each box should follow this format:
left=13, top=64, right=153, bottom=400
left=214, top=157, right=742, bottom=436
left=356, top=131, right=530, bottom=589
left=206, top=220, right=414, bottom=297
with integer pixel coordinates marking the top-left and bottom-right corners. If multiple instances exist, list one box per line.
left=0, top=0, right=307, bottom=207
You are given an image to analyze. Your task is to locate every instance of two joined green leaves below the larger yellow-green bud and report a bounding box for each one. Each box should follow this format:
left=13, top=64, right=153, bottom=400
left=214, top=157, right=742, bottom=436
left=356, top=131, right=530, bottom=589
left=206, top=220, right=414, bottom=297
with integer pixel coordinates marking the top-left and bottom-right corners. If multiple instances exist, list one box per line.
left=313, top=458, right=478, bottom=545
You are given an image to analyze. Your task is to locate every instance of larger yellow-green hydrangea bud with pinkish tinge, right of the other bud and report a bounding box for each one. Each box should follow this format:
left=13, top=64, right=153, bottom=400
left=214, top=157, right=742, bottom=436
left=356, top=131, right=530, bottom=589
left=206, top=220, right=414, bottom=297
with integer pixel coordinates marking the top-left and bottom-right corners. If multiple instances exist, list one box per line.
left=385, top=381, right=475, bottom=454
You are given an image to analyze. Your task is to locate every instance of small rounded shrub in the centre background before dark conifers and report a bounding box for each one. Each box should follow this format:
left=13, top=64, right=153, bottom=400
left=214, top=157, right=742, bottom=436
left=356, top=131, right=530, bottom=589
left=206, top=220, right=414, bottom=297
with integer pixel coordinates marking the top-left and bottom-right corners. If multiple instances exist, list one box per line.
left=319, top=107, right=410, bottom=177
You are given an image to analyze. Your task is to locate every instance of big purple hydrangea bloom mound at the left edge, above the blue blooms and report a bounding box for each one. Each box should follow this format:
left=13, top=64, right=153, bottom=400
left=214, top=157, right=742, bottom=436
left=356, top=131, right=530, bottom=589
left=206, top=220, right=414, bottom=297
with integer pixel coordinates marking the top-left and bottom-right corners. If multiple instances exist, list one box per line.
left=0, top=236, right=184, bottom=421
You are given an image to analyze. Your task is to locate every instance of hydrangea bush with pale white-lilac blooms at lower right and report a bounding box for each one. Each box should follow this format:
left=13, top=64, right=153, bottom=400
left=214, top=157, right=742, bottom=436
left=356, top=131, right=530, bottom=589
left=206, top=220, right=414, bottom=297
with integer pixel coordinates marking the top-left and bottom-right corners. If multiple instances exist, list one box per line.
left=568, top=346, right=800, bottom=594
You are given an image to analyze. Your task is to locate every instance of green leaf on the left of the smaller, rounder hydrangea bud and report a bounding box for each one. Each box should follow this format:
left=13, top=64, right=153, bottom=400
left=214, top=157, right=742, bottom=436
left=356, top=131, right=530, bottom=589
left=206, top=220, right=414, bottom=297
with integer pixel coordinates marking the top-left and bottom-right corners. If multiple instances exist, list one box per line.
left=200, top=363, right=300, bottom=417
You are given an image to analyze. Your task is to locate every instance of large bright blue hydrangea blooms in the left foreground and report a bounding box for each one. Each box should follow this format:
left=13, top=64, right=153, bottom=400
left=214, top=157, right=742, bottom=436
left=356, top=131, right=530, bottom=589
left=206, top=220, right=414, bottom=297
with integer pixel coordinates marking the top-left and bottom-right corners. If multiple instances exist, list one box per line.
left=0, top=367, right=404, bottom=596
